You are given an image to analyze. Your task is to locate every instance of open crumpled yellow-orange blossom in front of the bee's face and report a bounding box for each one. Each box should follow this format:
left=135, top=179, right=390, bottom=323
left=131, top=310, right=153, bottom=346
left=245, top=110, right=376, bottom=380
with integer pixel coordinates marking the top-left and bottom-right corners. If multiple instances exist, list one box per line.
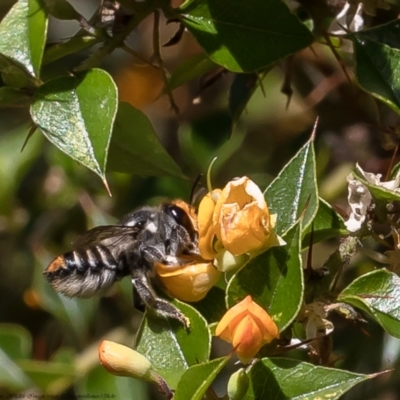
left=198, top=176, right=285, bottom=259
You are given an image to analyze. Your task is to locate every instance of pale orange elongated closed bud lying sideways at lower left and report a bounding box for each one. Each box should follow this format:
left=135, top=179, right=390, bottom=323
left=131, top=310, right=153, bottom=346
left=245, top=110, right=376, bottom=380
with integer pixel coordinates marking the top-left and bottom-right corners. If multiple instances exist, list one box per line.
left=98, top=340, right=158, bottom=382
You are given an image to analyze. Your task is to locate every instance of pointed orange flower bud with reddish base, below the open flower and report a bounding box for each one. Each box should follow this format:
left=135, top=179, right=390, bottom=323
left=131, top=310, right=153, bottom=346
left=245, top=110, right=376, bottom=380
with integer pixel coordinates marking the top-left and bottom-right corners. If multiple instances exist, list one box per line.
left=215, top=295, right=279, bottom=363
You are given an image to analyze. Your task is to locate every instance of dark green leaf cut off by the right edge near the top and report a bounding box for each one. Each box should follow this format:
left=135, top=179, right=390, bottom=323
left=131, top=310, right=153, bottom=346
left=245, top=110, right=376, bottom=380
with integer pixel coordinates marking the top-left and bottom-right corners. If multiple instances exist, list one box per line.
left=348, top=20, right=400, bottom=113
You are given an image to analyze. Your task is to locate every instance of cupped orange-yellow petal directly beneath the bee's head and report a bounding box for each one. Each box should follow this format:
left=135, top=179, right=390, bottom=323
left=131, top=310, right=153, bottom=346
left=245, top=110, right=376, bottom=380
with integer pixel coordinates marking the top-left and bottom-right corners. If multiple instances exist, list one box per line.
left=156, top=262, right=221, bottom=302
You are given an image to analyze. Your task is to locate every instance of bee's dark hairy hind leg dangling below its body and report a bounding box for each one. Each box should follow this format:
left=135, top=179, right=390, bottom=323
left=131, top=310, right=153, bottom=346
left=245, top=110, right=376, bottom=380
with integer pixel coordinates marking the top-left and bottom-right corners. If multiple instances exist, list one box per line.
left=132, top=273, right=190, bottom=330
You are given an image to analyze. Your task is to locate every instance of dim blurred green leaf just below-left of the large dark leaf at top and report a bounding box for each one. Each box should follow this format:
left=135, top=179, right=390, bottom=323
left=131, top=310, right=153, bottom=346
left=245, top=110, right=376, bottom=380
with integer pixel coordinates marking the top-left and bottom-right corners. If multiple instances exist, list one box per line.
left=168, top=53, right=219, bottom=90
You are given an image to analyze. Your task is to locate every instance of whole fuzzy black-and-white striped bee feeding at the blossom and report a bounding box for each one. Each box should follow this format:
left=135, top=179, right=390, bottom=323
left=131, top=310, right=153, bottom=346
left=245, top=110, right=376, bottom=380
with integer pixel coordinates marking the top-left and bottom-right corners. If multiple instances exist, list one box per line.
left=43, top=200, right=201, bottom=328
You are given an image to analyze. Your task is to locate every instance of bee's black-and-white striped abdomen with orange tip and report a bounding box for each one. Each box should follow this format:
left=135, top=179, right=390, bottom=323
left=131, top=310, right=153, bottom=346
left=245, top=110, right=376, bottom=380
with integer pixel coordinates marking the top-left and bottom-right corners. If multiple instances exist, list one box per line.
left=43, top=245, right=123, bottom=297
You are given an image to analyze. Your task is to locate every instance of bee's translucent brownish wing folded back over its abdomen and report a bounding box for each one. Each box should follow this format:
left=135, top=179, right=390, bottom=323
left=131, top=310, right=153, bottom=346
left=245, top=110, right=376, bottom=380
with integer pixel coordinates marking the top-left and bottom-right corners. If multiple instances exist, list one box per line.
left=73, top=225, right=139, bottom=249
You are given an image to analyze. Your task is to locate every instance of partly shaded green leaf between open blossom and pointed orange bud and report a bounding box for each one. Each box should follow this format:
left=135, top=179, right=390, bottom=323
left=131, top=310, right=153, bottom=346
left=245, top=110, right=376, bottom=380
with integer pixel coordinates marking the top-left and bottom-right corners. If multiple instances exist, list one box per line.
left=227, top=220, right=304, bottom=331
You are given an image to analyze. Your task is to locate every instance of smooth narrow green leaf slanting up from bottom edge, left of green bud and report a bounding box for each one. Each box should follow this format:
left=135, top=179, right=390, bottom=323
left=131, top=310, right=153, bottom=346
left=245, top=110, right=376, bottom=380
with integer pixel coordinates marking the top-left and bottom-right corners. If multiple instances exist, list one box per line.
left=174, top=356, right=230, bottom=400
